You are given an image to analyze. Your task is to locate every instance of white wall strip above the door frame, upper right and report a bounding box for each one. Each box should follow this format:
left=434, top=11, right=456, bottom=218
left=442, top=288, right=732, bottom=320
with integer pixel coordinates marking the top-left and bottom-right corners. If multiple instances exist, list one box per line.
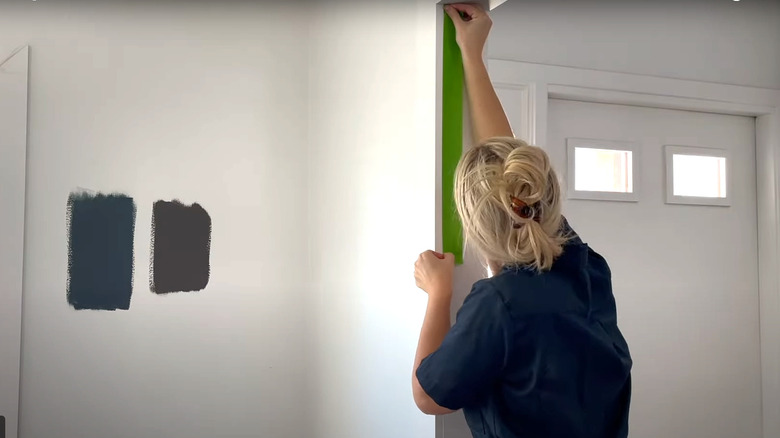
left=488, top=0, right=780, bottom=89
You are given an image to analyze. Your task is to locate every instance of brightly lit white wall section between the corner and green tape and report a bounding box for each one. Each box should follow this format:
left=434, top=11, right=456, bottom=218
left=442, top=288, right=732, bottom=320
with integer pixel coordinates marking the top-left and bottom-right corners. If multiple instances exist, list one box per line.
left=309, top=0, right=436, bottom=438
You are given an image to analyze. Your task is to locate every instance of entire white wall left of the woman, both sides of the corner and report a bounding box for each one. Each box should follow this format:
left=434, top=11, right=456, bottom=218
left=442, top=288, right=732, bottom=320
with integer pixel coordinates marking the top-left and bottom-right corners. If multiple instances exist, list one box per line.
left=0, top=0, right=437, bottom=438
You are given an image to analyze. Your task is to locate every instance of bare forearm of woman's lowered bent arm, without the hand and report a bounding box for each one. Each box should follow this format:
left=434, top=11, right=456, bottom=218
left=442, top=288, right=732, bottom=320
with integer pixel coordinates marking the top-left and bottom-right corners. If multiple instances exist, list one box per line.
left=412, top=296, right=452, bottom=414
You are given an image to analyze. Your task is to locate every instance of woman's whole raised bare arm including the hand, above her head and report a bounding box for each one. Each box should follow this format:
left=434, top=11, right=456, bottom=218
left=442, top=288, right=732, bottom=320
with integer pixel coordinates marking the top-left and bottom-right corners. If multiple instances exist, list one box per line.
left=445, top=4, right=514, bottom=144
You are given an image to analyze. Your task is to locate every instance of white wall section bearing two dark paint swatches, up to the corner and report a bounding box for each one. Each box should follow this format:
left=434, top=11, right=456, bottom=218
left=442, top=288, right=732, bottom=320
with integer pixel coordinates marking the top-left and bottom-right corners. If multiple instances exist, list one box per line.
left=0, top=1, right=313, bottom=438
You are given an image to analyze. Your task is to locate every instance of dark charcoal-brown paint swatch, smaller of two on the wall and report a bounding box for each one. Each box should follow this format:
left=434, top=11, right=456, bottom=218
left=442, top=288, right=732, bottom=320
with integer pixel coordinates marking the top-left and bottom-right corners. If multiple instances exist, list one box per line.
left=149, top=201, right=211, bottom=294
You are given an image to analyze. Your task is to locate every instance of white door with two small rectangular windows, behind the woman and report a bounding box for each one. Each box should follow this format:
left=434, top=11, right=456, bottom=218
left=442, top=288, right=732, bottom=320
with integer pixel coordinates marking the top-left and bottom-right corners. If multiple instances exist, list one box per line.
left=545, top=99, right=761, bottom=438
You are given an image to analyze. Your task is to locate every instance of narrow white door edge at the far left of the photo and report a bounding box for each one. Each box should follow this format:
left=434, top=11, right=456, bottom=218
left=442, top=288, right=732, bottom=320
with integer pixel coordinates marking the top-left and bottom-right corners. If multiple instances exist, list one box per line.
left=0, top=48, right=28, bottom=438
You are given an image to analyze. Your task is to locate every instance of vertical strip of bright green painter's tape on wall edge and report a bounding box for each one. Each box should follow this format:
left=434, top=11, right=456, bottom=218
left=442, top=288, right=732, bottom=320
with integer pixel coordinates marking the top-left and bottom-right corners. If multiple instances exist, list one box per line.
left=441, top=14, right=463, bottom=264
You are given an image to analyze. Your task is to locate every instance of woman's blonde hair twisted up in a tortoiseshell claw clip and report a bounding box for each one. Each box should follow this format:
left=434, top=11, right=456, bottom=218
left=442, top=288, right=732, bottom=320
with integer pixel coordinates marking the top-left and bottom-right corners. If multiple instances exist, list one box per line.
left=455, top=137, right=567, bottom=271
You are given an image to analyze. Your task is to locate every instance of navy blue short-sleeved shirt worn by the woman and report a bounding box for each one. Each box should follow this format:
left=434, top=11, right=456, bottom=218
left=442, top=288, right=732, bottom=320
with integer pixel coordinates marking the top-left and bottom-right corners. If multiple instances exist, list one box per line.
left=417, top=227, right=632, bottom=438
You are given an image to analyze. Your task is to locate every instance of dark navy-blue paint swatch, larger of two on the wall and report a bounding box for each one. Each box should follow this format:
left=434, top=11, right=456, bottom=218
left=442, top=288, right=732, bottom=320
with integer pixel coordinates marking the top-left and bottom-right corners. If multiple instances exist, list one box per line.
left=67, top=193, right=136, bottom=310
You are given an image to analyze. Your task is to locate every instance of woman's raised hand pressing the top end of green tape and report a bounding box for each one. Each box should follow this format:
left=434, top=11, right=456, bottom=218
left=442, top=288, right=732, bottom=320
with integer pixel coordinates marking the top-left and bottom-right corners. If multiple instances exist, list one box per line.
left=444, top=4, right=493, bottom=59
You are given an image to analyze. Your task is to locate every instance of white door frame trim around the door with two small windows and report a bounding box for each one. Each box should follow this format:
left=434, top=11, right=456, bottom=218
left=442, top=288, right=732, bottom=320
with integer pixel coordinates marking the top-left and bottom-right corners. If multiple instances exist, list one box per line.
left=488, top=59, right=780, bottom=438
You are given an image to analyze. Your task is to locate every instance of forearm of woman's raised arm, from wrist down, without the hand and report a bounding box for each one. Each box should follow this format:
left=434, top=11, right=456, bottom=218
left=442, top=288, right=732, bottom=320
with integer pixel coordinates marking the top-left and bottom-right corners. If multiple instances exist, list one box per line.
left=463, top=53, right=514, bottom=144
